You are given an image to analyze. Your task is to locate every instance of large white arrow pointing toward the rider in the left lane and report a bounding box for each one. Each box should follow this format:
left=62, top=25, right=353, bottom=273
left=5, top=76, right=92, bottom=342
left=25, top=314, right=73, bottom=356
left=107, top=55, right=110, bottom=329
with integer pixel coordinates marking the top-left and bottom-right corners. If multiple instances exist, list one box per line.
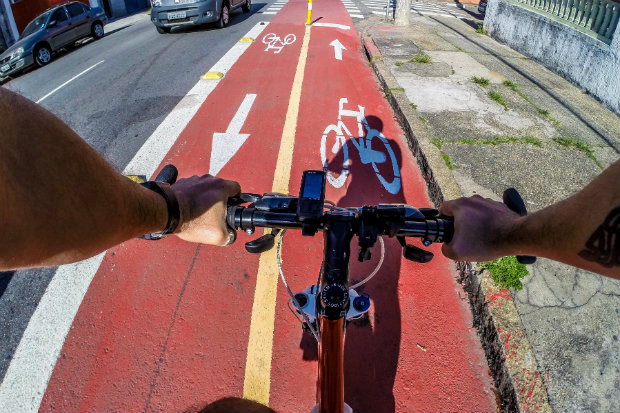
left=209, top=93, right=256, bottom=176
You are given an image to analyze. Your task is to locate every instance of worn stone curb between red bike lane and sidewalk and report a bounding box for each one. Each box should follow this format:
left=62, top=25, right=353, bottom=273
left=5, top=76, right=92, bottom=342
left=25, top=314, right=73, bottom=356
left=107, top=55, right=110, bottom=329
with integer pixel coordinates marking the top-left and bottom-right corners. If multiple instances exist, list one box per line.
left=361, top=35, right=552, bottom=413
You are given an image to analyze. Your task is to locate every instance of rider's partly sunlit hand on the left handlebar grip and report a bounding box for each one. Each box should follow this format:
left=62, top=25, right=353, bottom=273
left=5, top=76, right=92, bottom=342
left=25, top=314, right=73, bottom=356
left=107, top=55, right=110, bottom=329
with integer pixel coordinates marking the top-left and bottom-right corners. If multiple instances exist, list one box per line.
left=172, top=175, right=241, bottom=246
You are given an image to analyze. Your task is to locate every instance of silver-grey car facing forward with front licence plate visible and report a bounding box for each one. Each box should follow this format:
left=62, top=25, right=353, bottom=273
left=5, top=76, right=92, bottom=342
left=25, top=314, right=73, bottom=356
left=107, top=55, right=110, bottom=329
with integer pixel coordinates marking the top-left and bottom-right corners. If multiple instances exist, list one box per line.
left=151, top=0, right=252, bottom=33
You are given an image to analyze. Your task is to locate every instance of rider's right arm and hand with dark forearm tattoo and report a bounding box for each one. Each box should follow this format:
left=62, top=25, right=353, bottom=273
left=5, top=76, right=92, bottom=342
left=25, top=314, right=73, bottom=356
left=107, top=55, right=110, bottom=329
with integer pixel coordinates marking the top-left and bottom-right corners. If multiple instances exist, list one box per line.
left=440, top=161, right=620, bottom=278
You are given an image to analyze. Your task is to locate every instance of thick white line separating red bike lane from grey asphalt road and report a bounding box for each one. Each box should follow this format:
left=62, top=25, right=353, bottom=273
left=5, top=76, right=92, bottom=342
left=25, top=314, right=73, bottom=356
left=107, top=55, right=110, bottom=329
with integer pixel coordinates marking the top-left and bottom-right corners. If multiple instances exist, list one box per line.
left=0, top=22, right=268, bottom=413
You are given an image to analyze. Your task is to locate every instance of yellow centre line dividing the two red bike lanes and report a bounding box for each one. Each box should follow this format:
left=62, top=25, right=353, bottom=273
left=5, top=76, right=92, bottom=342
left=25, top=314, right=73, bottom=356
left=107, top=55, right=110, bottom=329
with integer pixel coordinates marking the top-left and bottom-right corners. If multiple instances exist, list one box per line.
left=243, top=26, right=311, bottom=405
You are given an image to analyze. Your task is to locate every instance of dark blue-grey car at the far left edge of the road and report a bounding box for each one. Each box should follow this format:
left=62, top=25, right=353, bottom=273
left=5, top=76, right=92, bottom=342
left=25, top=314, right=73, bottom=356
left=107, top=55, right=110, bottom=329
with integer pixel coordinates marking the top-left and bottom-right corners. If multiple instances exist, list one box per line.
left=0, top=2, right=108, bottom=77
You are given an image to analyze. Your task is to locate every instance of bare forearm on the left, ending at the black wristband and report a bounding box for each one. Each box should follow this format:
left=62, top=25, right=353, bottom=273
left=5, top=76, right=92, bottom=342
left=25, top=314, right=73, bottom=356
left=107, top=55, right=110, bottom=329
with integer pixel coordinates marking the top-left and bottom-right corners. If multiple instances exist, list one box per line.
left=0, top=89, right=167, bottom=269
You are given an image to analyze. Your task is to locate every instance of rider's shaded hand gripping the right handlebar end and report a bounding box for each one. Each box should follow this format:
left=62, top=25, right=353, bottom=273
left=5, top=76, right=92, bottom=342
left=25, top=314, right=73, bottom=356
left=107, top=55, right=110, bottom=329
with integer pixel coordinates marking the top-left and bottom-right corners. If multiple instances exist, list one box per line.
left=439, top=195, right=521, bottom=261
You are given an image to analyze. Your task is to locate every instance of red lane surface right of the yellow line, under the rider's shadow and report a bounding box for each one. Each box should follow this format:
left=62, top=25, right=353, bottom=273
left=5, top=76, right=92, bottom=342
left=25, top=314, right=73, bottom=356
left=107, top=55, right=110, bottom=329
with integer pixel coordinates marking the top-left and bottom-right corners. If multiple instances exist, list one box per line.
left=270, top=1, right=497, bottom=412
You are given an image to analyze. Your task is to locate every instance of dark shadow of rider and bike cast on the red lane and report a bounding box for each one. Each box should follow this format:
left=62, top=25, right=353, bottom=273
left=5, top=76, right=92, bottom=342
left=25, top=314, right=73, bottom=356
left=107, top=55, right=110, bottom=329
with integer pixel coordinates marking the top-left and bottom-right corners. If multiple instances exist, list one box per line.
left=300, top=116, right=405, bottom=412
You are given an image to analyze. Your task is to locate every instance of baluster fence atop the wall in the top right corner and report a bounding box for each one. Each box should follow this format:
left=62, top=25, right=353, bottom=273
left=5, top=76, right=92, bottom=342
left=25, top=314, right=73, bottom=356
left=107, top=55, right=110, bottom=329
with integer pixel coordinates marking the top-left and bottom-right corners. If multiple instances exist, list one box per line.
left=513, top=0, right=620, bottom=44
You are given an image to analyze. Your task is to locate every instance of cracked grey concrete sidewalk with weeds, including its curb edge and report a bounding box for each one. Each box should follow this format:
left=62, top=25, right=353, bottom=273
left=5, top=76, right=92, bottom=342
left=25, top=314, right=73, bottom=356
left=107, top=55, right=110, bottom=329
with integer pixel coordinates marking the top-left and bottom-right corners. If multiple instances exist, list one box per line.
left=357, top=5, right=620, bottom=413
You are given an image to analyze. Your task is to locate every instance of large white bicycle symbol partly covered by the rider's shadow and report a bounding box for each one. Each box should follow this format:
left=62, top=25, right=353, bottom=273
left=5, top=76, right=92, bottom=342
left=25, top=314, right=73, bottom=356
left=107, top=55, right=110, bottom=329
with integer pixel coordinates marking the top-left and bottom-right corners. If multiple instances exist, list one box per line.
left=321, top=98, right=400, bottom=194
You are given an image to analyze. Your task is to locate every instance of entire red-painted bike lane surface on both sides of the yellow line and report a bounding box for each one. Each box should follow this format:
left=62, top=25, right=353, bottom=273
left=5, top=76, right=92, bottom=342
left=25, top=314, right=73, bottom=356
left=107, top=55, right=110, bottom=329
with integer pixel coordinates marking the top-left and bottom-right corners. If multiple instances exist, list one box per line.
left=40, top=0, right=495, bottom=412
